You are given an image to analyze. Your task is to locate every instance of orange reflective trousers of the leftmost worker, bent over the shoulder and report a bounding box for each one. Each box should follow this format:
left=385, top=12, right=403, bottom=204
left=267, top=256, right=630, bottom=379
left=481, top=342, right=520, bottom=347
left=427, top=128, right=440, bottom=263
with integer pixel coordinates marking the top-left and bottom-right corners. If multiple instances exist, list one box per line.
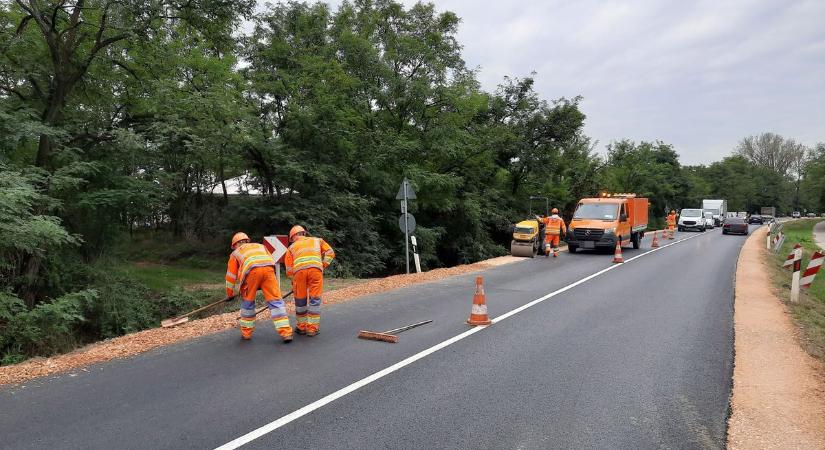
left=240, top=266, right=292, bottom=339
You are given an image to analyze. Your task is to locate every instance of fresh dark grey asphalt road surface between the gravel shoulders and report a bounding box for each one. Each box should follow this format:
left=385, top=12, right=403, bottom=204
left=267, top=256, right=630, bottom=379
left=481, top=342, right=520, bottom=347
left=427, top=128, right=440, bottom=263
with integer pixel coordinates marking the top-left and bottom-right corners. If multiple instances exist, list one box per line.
left=0, top=228, right=745, bottom=450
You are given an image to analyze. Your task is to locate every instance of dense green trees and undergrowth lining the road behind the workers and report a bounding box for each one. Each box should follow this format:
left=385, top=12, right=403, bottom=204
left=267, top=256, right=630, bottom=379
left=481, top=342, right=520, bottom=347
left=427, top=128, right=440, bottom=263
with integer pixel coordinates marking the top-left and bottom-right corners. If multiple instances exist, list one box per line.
left=0, top=0, right=825, bottom=364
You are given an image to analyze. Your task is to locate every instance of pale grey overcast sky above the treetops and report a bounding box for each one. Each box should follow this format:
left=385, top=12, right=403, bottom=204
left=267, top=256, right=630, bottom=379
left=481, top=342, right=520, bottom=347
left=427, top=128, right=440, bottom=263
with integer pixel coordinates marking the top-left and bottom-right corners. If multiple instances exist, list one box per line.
left=258, top=0, right=825, bottom=164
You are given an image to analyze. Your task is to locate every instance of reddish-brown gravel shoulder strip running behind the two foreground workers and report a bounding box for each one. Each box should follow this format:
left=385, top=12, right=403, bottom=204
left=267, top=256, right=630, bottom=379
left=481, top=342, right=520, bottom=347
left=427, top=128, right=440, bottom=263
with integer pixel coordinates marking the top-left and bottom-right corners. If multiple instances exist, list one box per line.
left=0, top=256, right=524, bottom=385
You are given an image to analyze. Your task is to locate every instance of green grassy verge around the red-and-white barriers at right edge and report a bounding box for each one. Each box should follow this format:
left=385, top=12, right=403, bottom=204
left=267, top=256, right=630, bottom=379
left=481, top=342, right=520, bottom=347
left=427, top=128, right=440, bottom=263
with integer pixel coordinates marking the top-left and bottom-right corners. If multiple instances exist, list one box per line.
left=770, top=219, right=825, bottom=362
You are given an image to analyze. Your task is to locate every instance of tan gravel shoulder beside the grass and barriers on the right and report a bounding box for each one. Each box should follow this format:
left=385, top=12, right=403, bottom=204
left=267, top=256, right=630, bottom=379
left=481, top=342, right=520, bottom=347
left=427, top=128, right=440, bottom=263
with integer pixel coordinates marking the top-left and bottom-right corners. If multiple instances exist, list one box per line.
left=728, top=228, right=825, bottom=450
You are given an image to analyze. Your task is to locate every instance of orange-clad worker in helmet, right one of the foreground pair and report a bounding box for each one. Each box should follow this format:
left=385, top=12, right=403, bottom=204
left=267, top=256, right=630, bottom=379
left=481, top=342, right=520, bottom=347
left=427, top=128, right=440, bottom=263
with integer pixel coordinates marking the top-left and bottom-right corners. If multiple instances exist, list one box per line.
left=284, top=225, right=335, bottom=336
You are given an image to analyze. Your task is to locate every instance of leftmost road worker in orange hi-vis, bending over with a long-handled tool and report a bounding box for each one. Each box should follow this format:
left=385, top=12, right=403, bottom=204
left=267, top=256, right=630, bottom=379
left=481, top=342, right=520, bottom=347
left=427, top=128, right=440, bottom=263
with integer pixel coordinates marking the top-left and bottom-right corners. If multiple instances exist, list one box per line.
left=226, top=233, right=292, bottom=343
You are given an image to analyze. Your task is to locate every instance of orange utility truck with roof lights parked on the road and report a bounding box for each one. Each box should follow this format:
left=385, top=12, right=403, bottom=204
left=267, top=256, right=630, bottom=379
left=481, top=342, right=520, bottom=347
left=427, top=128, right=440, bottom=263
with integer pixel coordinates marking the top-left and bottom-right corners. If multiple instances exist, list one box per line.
left=567, top=193, right=648, bottom=253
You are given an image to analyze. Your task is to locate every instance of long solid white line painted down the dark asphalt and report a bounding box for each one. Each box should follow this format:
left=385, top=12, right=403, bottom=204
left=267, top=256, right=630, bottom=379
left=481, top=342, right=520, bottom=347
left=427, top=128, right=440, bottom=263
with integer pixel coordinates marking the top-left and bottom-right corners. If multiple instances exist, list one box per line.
left=217, top=233, right=705, bottom=450
